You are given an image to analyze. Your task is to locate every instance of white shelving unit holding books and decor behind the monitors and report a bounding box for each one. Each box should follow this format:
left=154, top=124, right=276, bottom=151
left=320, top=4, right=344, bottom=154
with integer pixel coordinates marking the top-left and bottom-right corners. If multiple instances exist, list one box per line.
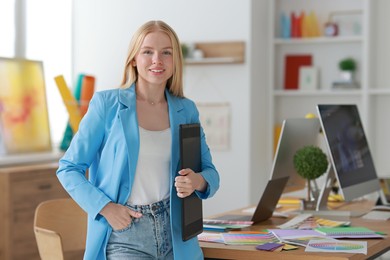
left=268, top=0, right=390, bottom=177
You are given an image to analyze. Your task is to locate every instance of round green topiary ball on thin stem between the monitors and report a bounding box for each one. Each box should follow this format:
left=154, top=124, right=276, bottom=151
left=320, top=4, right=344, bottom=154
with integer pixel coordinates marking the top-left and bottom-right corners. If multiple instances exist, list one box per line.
left=293, top=145, right=329, bottom=208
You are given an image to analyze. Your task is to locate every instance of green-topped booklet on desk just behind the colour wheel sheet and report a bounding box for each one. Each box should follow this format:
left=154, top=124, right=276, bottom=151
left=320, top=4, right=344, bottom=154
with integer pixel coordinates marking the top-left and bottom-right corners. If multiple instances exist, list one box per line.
left=314, top=227, right=383, bottom=238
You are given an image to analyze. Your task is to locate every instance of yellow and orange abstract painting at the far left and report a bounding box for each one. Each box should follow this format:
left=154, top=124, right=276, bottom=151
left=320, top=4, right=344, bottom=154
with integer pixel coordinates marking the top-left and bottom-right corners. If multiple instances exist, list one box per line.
left=0, top=58, right=52, bottom=154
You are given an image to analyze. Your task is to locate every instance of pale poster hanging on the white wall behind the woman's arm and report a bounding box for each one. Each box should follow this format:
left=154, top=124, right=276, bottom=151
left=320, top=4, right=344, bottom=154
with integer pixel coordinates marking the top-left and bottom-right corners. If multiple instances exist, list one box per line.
left=196, top=103, right=230, bottom=151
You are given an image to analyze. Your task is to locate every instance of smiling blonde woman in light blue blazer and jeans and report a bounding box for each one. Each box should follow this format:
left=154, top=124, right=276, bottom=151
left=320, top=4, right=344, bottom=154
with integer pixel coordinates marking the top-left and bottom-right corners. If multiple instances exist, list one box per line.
left=57, top=21, right=219, bottom=260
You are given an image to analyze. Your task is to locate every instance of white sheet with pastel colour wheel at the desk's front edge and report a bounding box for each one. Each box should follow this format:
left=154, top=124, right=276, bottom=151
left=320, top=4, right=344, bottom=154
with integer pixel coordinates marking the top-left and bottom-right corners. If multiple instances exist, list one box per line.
left=305, top=240, right=367, bottom=255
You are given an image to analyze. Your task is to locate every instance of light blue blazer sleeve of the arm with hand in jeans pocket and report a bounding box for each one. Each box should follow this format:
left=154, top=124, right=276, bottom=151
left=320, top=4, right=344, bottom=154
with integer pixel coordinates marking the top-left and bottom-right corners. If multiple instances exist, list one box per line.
left=57, top=92, right=111, bottom=218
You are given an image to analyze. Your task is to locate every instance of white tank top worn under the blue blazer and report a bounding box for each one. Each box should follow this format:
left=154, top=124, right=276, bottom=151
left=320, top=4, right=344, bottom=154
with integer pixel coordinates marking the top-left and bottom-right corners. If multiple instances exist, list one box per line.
left=128, top=127, right=172, bottom=205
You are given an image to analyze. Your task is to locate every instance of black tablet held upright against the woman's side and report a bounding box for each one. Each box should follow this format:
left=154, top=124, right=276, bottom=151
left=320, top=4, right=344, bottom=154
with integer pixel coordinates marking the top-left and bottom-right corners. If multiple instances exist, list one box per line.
left=180, top=124, right=203, bottom=241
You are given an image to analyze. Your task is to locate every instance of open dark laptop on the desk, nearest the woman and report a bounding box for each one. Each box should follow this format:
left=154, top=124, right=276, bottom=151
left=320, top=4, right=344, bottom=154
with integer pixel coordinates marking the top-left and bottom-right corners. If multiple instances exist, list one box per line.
left=213, top=176, right=289, bottom=223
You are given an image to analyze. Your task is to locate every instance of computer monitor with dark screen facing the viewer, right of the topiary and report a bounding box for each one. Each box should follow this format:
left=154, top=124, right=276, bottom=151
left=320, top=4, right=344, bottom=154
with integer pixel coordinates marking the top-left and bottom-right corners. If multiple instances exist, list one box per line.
left=317, top=104, right=380, bottom=201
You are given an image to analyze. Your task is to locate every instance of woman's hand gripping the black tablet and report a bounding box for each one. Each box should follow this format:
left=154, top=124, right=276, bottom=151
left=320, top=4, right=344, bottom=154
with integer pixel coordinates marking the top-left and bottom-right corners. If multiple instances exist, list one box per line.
left=175, top=169, right=207, bottom=198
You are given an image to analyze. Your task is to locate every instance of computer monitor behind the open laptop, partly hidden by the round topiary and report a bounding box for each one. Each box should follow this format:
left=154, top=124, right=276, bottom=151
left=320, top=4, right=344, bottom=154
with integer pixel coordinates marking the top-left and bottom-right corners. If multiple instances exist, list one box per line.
left=271, top=118, right=321, bottom=192
